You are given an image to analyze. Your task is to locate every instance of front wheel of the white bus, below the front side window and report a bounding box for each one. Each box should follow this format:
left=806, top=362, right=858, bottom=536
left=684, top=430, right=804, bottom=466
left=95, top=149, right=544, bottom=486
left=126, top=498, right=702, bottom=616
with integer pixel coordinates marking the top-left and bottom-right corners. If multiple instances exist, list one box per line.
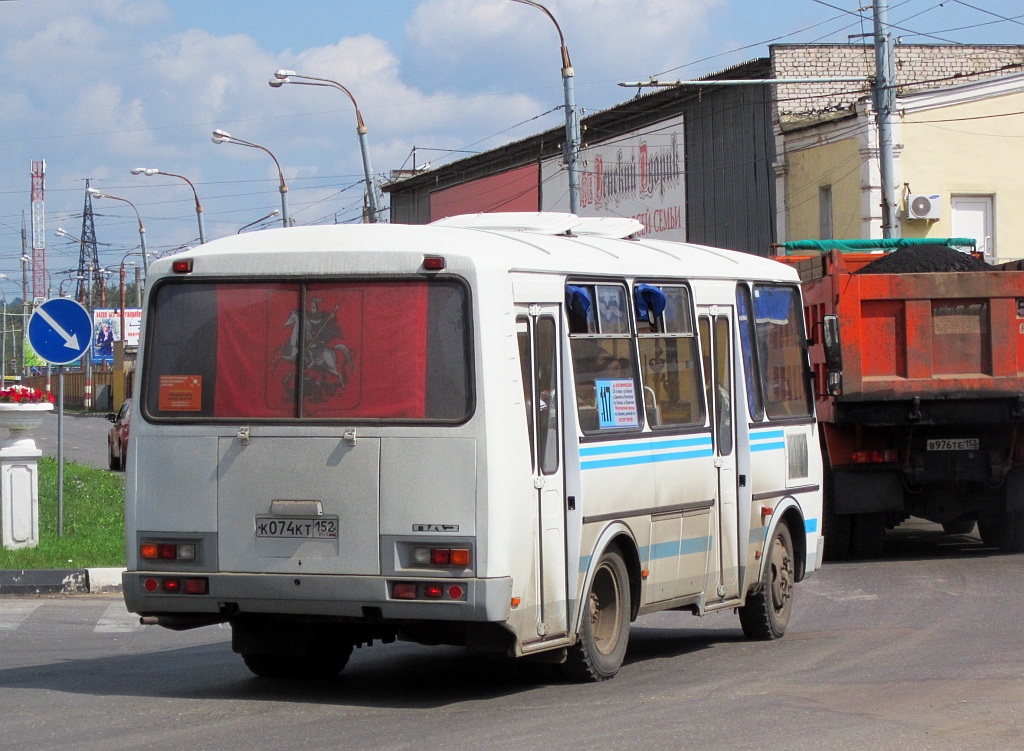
left=739, top=523, right=797, bottom=640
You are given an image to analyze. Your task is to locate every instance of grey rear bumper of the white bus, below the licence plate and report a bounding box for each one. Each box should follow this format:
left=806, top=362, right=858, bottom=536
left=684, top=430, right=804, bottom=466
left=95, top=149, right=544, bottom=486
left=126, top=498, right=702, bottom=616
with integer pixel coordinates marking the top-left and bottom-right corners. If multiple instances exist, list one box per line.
left=122, top=571, right=512, bottom=627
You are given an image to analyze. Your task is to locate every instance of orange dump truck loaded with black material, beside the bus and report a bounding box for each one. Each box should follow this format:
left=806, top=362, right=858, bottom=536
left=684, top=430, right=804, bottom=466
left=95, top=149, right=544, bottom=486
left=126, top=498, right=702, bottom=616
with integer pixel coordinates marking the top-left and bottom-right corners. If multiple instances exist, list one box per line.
left=778, top=241, right=1024, bottom=559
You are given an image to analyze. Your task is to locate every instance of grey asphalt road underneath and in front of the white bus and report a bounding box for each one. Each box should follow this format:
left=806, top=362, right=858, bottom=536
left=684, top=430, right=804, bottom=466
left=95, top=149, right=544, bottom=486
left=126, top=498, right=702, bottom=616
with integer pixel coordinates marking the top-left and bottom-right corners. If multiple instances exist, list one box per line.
left=0, top=523, right=1024, bottom=751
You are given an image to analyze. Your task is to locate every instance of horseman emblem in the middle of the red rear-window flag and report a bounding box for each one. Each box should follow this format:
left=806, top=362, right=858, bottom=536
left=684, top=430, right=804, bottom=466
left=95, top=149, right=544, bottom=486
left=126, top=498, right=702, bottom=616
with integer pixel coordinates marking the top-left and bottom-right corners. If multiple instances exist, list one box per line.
left=278, top=297, right=355, bottom=403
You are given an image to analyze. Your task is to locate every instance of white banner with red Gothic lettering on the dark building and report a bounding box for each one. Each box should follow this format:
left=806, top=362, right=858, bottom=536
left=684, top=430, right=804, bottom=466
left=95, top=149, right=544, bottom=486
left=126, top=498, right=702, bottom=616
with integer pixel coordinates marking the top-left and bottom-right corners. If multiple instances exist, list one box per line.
left=541, top=115, right=686, bottom=241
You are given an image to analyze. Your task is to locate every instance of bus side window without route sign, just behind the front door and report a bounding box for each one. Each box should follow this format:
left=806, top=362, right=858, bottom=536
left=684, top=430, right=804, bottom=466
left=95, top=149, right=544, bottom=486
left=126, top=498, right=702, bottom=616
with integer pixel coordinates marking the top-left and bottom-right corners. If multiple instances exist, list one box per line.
left=634, top=285, right=705, bottom=429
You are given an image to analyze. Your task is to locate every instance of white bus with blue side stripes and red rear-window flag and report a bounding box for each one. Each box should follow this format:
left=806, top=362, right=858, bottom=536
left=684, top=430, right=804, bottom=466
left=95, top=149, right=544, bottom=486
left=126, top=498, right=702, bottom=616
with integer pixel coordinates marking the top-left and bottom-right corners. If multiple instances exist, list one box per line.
left=124, top=209, right=822, bottom=680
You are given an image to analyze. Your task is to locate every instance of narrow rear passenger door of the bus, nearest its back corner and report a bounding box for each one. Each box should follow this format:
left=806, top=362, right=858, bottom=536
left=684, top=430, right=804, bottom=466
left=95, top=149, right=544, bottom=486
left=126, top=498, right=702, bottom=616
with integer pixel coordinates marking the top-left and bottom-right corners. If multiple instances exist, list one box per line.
left=516, top=305, right=568, bottom=639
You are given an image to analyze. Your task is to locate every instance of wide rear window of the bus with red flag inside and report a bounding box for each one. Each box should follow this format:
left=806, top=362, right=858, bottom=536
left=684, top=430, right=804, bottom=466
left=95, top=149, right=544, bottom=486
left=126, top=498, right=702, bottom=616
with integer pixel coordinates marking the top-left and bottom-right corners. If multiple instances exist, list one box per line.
left=143, top=280, right=472, bottom=422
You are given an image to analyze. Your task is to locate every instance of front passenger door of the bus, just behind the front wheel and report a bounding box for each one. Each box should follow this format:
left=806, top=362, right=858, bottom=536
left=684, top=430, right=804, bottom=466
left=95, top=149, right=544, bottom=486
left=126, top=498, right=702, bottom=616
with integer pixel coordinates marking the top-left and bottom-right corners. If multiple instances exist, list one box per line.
left=698, top=305, right=745, bottom=602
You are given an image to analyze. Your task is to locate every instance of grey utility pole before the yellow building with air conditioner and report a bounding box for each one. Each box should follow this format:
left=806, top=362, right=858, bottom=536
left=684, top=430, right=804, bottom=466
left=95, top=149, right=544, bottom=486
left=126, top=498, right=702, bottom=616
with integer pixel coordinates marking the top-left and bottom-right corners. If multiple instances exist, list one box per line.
left=871, top=0, right=899, bottom=240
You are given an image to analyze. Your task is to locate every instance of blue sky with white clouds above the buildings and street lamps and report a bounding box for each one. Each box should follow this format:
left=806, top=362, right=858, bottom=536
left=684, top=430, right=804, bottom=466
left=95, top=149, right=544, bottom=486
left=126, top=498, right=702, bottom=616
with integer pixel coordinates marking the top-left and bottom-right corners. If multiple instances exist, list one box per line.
left=0, top=0, right=1024, bottom=299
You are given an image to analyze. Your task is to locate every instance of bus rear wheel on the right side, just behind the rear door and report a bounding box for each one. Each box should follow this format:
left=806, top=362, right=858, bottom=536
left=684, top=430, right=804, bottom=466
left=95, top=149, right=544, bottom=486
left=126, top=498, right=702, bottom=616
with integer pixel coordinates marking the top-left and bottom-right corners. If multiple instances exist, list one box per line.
left=561, top=548, right=630, bottom=682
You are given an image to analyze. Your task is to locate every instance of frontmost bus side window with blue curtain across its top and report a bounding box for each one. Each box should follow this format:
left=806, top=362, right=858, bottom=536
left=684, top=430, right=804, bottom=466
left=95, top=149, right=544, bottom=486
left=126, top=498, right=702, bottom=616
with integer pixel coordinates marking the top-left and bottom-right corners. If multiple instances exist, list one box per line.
left=754, top=284, right=811, bottom=418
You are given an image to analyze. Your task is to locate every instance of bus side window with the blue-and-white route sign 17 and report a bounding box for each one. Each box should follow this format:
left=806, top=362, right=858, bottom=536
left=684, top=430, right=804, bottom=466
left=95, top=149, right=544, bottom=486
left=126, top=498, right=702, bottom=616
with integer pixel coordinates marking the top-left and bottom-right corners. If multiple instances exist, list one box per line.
left=565, top=284, right=641, bottom=433
